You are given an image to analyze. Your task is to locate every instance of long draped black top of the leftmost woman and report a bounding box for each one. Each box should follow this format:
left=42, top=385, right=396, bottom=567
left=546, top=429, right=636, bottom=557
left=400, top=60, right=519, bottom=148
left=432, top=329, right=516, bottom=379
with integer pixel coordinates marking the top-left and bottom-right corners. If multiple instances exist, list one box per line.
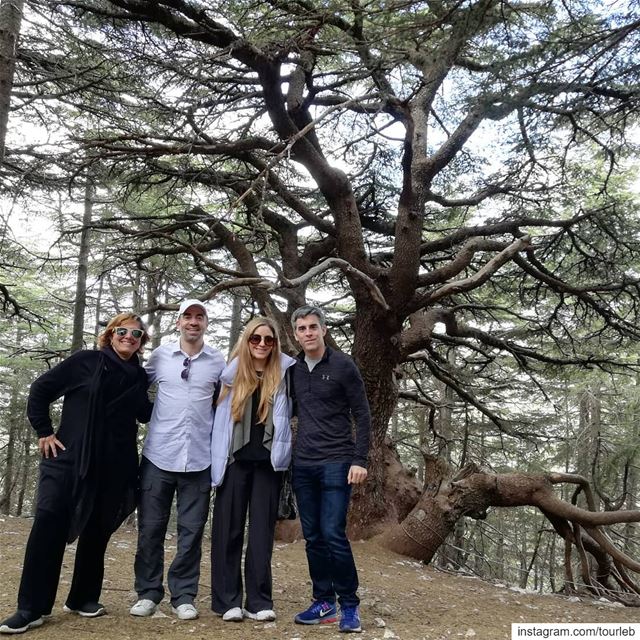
left=27, top=347, right=153, bottom=542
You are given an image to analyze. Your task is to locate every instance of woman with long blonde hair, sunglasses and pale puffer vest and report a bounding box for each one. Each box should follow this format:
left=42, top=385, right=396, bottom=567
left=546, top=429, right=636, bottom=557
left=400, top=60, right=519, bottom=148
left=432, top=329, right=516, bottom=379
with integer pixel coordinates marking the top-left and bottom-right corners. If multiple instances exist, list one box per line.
left=211, top=318, right=295, bottom=622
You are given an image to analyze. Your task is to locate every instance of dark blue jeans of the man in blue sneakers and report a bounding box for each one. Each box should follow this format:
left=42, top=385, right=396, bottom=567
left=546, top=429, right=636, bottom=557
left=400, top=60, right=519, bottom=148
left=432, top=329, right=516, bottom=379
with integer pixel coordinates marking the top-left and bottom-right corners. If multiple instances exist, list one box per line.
left=292, top=462, right=360, bottom=607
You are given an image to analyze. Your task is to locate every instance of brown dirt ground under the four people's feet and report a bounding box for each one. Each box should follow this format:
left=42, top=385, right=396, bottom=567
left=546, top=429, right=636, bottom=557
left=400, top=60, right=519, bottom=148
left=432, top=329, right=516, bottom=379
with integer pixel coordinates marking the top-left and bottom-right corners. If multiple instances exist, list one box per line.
left=0, top=517, right=639, bottom=640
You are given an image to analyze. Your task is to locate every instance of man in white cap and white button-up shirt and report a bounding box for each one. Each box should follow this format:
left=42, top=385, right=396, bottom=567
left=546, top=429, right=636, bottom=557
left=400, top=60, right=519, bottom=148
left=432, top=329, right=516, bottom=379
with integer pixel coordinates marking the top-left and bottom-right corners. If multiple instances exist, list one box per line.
left=130, top=300, right=225, bottom=620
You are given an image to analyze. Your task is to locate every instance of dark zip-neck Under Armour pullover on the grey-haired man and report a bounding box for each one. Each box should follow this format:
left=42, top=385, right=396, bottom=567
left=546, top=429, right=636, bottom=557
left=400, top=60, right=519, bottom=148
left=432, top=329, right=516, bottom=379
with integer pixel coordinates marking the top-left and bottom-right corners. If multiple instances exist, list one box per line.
left=293, top=347, right=371, bottom=467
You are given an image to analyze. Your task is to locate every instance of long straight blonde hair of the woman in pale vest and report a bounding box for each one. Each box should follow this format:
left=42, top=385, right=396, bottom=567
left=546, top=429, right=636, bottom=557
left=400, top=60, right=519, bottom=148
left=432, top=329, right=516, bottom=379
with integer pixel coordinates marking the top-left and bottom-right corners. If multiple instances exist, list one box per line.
left=226, top=317, right=282, bottom=422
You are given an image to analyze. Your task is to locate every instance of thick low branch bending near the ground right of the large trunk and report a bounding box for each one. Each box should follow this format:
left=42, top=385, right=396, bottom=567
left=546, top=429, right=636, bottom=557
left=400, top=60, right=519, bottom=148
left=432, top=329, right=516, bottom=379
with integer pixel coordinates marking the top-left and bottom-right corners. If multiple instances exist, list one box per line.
left=382, top=454, right=640, bottom=606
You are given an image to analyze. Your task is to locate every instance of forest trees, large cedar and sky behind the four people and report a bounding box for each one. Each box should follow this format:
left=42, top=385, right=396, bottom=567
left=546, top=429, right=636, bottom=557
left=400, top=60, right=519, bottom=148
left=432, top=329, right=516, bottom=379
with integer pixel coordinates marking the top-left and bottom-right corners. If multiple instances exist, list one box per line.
left=0, top=0, right=640, bottom=604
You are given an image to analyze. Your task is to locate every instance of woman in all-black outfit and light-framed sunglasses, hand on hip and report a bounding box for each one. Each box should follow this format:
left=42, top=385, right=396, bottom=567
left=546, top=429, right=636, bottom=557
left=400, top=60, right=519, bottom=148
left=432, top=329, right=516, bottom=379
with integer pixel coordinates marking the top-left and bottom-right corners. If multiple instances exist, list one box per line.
left=0, top=313, right=152, bottom=633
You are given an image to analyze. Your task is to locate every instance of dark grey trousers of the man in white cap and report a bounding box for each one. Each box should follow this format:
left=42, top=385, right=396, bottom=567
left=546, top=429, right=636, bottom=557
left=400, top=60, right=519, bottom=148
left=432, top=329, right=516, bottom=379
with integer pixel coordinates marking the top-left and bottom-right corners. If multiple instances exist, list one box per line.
left=134, top=457, right=211, bottom=607
